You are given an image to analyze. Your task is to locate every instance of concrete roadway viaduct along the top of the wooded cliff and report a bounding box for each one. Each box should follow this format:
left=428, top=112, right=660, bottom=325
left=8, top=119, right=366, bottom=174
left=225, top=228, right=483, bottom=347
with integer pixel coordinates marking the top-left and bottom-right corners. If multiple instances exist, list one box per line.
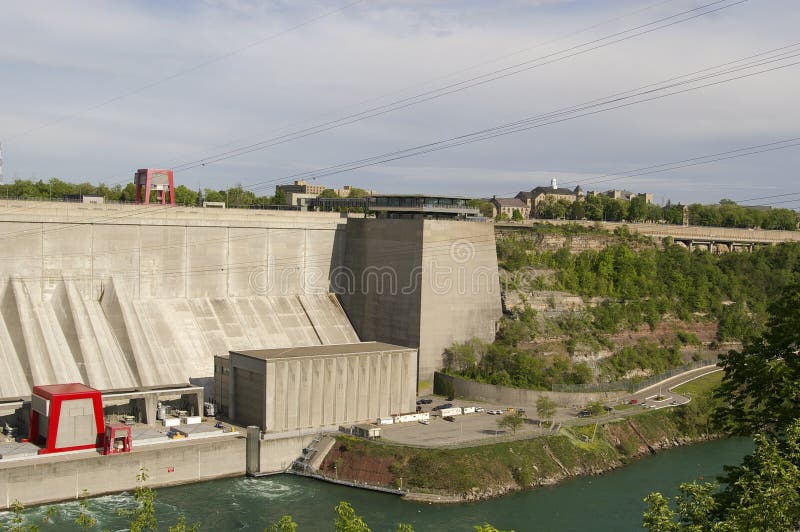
left=495, top=220, right=800, bottom=253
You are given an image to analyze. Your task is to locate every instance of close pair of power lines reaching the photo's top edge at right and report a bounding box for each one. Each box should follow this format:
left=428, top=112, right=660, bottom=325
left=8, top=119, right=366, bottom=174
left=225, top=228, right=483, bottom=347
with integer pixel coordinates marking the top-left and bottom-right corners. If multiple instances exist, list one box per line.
left=173, top=0, right=747, bottom=171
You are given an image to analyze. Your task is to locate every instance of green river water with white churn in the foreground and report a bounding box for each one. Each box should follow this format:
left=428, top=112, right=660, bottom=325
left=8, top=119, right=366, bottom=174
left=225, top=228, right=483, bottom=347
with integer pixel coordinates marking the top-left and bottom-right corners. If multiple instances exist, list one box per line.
left=6, top=438, right=752, bottom=532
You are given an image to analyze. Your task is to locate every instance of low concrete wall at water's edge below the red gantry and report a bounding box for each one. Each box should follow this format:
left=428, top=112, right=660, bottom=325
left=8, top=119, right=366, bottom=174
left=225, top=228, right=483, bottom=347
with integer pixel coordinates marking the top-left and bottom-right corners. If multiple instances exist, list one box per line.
left=0, top=436, right=245, bottom=509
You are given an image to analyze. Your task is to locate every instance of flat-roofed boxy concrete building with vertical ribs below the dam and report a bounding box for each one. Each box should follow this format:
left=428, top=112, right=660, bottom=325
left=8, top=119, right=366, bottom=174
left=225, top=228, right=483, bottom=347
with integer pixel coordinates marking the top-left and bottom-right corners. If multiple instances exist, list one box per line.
left=222, top=342, right=417, bottom=431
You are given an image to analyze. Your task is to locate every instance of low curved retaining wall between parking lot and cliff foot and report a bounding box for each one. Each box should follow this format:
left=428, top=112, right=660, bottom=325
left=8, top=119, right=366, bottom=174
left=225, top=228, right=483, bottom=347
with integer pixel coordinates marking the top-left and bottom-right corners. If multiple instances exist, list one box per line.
left=438, top=373, right=627, bottom=408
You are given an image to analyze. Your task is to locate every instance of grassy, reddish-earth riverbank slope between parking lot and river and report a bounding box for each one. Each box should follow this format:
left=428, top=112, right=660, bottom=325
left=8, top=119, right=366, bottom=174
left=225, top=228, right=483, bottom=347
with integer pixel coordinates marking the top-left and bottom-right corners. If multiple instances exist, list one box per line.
left=320, top=370, right=719, bottom=502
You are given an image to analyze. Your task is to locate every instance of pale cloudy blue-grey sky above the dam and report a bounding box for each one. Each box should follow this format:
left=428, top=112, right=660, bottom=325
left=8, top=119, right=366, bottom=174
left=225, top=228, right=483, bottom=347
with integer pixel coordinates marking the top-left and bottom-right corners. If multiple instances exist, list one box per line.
left=0, top=0, right=800, bottom=209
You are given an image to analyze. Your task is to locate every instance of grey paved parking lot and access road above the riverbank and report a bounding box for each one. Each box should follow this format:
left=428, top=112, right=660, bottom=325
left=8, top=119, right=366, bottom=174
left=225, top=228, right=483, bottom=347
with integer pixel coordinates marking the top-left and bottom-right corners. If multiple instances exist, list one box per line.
left=381, top=366, right=720, bottom=447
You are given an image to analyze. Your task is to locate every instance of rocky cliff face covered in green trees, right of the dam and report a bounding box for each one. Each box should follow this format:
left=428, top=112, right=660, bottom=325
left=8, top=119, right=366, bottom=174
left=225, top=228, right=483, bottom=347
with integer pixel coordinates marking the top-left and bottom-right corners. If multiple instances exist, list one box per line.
left=443, top=231, right=800, bottom=389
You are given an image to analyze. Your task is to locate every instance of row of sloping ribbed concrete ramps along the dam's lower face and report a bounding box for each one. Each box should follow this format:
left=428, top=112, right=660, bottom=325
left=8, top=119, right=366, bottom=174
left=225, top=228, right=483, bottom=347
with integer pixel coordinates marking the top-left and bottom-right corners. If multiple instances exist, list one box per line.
left=0, top=276, right=358, bottom=398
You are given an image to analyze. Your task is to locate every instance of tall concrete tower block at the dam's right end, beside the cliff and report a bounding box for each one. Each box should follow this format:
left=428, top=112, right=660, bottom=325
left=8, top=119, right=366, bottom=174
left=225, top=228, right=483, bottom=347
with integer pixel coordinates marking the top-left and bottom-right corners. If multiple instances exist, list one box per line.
left=340, top=219, right=502, bottom=392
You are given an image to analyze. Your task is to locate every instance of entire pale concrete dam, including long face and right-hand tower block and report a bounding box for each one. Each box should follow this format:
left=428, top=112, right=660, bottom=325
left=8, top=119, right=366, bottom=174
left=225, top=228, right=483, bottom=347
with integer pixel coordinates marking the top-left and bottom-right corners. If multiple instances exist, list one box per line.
left=0, top=201, right=500, bottom=398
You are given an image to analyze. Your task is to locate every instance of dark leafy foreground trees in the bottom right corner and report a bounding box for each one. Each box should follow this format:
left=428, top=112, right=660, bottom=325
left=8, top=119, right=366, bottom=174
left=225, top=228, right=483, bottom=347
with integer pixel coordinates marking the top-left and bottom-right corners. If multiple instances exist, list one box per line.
left=644, top=267, right=800, bottom=532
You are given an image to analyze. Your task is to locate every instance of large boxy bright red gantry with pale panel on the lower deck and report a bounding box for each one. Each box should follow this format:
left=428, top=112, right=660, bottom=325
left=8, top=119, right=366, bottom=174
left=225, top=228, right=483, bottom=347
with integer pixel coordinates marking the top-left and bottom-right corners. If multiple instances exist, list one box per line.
left=30, top=383, right=105, bottom=454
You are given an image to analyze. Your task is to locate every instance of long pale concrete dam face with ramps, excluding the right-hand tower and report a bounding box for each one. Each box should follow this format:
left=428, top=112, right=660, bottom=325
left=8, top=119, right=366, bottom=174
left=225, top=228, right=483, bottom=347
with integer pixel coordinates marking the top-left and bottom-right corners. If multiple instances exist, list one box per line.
left=0, top=201, right=358, bottom=398
